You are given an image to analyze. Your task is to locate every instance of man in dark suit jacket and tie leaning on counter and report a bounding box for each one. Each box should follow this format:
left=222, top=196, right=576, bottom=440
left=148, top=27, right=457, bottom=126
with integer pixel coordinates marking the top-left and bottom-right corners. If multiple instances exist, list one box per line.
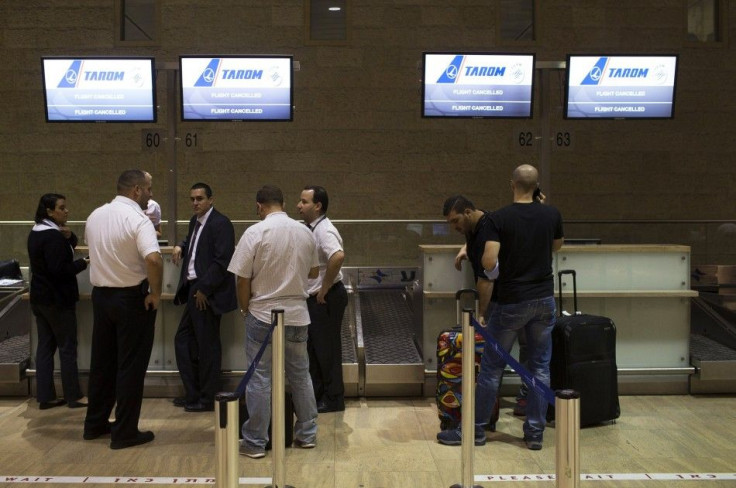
left=172, top=183, right=238, bottom=412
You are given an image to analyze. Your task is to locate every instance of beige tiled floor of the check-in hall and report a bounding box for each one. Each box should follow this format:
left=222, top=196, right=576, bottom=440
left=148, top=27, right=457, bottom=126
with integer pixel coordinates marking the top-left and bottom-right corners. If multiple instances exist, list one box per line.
left=0, top=396, right=736, bottom=488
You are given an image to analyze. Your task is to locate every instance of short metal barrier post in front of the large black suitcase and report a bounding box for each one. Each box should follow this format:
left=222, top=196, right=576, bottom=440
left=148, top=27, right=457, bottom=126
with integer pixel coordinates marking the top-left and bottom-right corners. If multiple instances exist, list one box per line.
left=555, top=390, right=580, bottom=488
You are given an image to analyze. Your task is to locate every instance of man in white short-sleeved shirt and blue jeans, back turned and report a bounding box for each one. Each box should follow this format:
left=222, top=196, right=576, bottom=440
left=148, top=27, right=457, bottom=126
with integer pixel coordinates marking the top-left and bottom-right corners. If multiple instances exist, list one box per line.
left=228, top=186, right=319, bottom=458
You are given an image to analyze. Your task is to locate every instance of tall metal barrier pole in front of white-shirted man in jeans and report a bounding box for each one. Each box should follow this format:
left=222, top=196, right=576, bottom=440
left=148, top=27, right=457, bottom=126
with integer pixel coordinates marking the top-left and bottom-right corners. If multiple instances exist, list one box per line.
left=266, top=309, right=293, bottom=488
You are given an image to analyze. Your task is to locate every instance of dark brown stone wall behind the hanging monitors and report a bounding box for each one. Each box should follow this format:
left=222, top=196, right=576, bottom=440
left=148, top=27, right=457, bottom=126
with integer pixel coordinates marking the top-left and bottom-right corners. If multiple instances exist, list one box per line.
left=0, top=0, right=736, bottom=264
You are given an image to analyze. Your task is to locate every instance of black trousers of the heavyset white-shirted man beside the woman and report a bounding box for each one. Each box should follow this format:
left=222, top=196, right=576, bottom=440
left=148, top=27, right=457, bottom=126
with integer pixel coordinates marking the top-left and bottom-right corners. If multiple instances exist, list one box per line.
left=84, top=282, right=156, bottom=441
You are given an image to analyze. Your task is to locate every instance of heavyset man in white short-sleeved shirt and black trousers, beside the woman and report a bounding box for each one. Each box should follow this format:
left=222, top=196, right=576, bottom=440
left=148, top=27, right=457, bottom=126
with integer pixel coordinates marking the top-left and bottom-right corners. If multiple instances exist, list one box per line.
left=84, top=169, right=163, bottom=449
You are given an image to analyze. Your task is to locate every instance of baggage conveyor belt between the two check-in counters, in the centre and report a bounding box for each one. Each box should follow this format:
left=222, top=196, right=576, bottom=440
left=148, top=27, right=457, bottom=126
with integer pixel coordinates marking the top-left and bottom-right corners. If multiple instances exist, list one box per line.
left=354, top=289, right=424, bottom=396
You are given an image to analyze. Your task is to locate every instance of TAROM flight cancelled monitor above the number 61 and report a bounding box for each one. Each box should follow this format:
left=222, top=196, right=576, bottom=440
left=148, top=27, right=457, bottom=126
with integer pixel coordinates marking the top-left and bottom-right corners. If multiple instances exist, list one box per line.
left=179, top=55, right=294, bottom=121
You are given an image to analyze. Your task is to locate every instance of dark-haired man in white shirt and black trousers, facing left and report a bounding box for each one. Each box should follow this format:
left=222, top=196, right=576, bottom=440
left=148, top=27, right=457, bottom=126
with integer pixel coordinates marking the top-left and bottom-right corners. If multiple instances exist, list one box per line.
left=297, top=186, right=348, bottom=413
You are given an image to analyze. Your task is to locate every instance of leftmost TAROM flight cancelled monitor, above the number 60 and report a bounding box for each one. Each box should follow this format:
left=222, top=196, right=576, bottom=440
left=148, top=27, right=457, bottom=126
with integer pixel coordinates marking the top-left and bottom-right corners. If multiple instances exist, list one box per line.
left=41, top=57, right=156, bottom=122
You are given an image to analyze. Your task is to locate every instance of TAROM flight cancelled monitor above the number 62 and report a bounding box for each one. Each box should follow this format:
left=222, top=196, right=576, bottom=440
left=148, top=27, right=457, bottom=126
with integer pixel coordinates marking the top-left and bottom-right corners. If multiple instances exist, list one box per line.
left=422, top=53, right=534, bottom=118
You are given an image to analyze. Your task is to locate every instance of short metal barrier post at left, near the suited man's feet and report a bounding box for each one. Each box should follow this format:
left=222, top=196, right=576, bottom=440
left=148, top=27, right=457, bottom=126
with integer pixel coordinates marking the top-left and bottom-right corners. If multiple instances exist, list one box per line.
left=215, top=393, right=240, bottom=488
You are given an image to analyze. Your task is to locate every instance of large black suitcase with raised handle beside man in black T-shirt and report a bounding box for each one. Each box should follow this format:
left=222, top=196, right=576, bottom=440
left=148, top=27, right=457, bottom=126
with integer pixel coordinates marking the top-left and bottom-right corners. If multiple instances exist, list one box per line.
left=548, top=269, right=621, bottom=426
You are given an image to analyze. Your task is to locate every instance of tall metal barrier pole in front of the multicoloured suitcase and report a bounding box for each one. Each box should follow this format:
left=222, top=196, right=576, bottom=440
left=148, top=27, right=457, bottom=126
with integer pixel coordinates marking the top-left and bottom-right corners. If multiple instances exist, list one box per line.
left=450, top=308, right=481, bottom=488
